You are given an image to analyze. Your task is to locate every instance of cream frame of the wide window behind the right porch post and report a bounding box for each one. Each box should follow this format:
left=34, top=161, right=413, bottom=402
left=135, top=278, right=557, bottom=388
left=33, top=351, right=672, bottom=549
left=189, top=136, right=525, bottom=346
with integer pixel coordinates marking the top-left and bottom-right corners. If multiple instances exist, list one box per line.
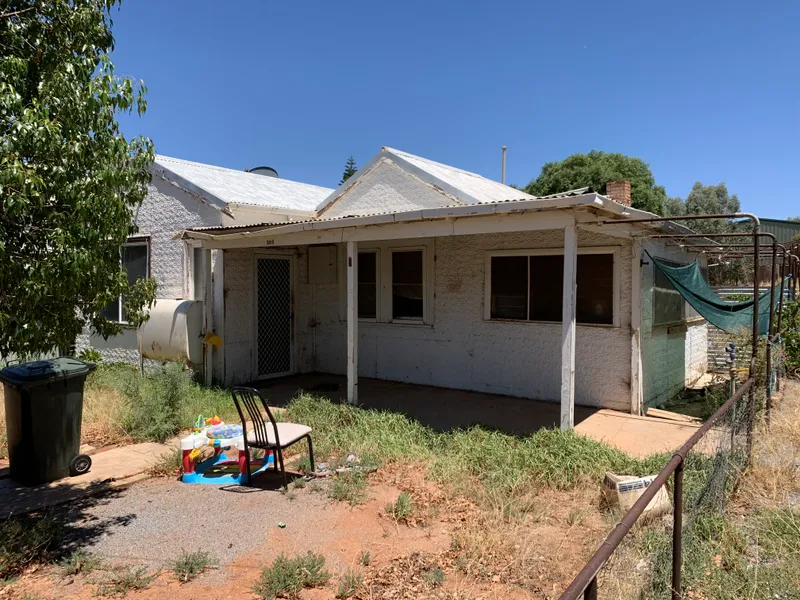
left=483, top=246, right=621, bottom=328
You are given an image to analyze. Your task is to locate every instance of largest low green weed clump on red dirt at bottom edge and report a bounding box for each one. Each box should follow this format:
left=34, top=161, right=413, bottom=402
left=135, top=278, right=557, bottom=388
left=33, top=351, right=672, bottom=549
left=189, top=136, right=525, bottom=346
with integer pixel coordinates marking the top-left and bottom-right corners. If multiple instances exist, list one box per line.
left=253, top=552, right=331, bottom=600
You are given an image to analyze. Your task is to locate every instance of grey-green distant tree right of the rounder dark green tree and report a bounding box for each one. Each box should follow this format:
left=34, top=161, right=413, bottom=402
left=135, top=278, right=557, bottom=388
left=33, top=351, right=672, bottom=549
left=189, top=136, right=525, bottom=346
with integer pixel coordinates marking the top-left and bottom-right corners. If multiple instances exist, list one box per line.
left=665, top=181, right=741, bottom=233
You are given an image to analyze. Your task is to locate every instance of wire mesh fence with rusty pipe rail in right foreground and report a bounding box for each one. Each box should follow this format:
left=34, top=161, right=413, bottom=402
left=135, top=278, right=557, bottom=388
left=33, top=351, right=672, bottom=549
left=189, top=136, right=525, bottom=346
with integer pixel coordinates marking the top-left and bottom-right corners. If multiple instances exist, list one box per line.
left=561, top=379, right=752, bottom=600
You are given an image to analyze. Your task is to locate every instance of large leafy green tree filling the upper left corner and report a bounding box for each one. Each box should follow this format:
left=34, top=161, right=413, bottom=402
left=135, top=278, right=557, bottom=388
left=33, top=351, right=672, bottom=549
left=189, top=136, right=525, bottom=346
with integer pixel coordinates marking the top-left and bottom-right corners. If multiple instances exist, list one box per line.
left=0, top=0, right=155, bottom=356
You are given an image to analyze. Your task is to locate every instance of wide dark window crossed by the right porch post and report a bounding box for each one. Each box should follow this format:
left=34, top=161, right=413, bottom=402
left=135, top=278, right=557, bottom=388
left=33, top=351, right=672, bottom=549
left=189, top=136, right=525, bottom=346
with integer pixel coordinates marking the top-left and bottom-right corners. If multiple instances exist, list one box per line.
left=487, top=249, right=616, bottom=325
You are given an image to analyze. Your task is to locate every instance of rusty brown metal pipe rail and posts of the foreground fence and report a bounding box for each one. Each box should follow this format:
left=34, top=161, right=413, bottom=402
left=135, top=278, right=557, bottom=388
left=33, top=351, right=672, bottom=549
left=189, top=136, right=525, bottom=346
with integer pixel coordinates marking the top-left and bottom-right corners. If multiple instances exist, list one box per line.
left=559, top=379, right=755, bottom=600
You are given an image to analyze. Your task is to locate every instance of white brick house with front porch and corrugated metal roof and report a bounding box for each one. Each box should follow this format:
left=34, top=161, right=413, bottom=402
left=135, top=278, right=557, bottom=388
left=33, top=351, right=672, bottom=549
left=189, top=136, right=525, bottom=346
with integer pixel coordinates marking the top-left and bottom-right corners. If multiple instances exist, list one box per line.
left=161, top=148, right=707, bottom=427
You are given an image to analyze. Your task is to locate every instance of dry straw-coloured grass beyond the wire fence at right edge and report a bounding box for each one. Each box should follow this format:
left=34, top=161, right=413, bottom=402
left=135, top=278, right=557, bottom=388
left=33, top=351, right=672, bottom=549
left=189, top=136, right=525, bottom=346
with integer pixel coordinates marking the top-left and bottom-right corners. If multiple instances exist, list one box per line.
left=737, top=379, right=800, bottom=507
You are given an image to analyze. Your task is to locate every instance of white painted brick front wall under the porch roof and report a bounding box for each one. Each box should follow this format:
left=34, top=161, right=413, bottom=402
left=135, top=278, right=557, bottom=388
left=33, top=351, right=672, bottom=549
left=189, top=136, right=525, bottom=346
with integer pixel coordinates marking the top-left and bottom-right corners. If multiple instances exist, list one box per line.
left=224, top=231, right=631, bottom=410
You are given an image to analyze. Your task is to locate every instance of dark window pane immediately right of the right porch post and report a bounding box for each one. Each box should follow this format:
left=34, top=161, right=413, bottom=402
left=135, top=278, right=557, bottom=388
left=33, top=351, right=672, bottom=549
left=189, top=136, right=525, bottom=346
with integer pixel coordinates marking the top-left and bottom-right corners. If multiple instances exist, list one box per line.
left=575, top=254, right=614, bottom=325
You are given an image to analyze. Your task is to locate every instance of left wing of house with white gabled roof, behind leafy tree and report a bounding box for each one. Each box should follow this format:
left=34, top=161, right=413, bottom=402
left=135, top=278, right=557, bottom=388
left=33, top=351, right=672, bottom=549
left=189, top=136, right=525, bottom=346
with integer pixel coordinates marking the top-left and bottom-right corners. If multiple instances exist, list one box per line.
left=76, top=156, right=333, bottom=379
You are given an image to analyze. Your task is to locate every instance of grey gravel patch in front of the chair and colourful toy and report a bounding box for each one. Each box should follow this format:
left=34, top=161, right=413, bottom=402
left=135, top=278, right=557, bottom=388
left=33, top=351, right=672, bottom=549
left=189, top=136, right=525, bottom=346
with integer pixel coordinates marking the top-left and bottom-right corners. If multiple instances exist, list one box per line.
left=63, top=479, right=328, bottom=566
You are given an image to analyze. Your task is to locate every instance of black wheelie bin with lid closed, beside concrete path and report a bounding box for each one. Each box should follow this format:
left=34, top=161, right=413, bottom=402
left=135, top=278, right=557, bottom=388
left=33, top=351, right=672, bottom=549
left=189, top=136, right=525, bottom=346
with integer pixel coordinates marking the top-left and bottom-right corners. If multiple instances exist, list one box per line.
left=0, top=357, right=95, bottom=485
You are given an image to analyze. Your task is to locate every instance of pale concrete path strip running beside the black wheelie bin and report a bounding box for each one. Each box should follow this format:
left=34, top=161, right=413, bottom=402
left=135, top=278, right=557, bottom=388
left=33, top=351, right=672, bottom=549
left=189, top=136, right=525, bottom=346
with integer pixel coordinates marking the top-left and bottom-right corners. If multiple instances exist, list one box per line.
left=0, top=442, right=174, bottom=518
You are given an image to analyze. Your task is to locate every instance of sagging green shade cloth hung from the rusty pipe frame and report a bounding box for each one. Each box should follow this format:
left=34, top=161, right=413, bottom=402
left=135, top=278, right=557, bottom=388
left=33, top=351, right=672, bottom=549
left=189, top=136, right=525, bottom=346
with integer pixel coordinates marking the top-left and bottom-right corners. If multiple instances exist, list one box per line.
left=650, top=256, right=788, bottom=334
